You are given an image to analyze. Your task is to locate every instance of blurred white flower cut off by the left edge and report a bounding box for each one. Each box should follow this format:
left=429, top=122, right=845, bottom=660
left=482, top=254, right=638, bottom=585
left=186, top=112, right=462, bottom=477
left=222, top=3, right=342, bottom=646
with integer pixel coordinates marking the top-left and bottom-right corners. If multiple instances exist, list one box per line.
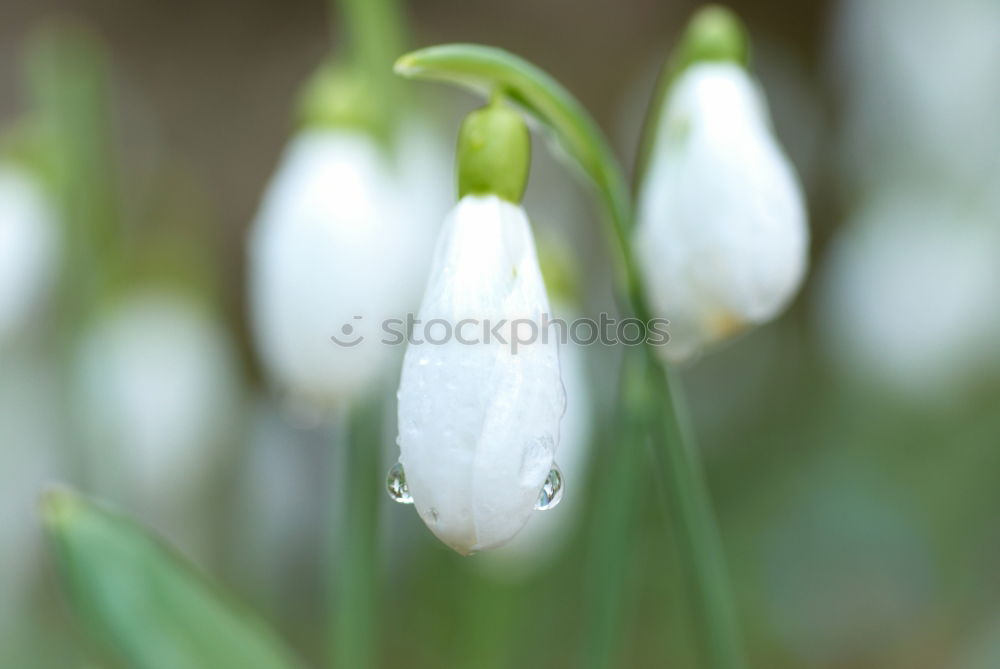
left=0, top=165, right=58, bottom=340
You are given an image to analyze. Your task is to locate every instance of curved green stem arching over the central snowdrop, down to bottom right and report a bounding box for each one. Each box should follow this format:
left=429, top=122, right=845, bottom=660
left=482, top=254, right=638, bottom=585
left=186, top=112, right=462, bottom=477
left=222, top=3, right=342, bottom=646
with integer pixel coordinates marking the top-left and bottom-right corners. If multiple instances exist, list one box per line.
left=396, top=44, right=745, bottom=669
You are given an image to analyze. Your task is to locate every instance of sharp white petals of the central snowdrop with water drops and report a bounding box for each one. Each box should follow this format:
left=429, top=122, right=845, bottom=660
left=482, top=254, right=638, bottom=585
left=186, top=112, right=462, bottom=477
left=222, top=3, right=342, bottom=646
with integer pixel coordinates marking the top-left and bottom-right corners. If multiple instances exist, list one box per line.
left=399, top=195, right=565, bottom=554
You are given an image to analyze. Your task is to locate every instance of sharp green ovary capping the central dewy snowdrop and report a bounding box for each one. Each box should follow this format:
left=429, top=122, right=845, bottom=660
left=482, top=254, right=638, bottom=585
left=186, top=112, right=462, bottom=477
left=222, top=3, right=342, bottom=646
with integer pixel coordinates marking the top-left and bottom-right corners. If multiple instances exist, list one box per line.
left=457, top=95, right=531, bottom=204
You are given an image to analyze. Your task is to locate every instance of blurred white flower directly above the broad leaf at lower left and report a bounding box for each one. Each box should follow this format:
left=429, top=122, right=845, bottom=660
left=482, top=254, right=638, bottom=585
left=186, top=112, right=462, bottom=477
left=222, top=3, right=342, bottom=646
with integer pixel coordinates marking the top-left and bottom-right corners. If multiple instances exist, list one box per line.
left=73, top=289, right=240, bottom=543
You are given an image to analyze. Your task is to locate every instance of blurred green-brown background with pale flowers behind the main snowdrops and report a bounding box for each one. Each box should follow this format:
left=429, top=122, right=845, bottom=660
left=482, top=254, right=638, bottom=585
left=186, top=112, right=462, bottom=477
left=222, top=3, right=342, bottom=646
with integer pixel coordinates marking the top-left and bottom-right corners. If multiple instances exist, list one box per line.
left=0, top=0, right=1000, bottom=669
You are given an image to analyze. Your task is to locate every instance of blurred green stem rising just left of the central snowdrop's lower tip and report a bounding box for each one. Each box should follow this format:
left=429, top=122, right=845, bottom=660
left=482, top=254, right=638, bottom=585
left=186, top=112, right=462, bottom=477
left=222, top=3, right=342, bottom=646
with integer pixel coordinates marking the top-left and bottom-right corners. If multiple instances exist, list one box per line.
left=330, top=405, right=385, bottom=669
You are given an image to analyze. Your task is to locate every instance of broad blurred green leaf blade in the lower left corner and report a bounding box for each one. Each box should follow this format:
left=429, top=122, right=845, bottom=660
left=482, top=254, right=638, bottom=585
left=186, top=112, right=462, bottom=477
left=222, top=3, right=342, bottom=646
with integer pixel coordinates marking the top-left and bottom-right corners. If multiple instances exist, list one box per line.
left=42, top=490, right=301, bottom=669
